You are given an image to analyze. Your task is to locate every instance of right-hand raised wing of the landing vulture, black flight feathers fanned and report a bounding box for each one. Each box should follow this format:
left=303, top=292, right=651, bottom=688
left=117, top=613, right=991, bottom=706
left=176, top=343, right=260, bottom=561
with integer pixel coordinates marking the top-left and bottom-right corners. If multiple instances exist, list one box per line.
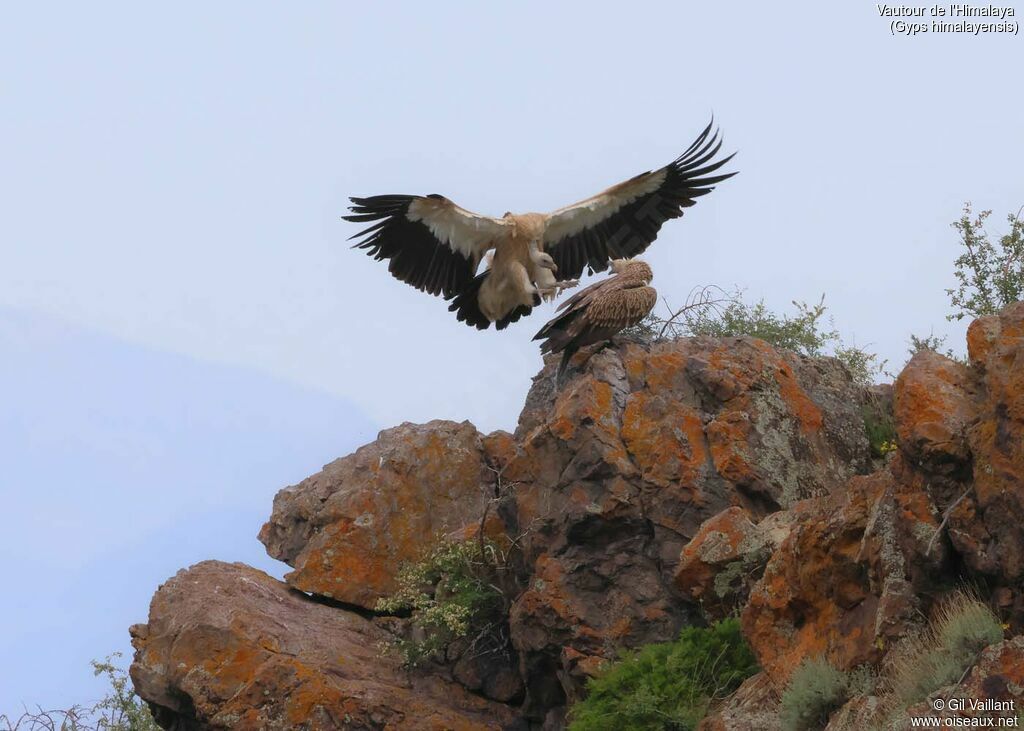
left=544, top=121, right=735, bottom=280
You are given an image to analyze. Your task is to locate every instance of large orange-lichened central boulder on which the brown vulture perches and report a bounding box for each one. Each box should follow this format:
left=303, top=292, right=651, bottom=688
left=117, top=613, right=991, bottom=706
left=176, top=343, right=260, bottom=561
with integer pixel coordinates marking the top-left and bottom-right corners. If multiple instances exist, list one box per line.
left=495, top=338, right=869, bottom=713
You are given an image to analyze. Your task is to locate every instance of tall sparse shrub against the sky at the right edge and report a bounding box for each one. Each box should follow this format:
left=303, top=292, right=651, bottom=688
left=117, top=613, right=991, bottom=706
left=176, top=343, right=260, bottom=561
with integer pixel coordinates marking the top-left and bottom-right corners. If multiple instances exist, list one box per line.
left=946, top=203, right=1024, bottom=319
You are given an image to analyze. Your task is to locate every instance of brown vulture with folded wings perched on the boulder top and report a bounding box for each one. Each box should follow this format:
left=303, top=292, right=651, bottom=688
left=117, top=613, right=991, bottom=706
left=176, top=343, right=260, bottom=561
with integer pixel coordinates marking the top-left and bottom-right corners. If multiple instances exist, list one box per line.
left=534, top=259, right=657, bottom=382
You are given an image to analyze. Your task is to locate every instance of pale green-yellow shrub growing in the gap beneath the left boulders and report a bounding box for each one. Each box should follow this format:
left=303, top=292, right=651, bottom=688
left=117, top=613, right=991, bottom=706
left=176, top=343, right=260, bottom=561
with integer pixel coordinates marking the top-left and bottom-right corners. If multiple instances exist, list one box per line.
left=375, top=541, right=506, bottom=668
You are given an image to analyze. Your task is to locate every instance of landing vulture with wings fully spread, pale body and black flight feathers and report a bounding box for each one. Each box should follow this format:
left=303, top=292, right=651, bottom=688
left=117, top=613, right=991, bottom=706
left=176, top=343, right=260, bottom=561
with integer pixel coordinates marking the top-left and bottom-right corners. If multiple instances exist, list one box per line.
left=344, top=122, right=735, bottom=330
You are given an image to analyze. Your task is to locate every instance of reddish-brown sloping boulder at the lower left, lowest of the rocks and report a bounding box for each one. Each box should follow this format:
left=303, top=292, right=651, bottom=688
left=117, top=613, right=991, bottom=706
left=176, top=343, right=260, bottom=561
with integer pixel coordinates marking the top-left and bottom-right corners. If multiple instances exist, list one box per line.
left=131, top=561, right=525, bottom=731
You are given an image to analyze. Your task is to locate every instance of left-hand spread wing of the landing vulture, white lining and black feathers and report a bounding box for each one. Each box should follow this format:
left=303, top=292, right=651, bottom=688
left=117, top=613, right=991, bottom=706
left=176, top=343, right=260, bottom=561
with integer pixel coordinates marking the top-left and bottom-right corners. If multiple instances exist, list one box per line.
left=343, top=195, right=509, bottom=299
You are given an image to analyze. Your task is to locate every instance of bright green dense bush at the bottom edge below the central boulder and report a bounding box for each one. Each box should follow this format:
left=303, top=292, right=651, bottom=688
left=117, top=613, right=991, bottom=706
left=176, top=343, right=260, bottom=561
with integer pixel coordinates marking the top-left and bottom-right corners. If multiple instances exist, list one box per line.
left=569, top=617, right=759, bottom=731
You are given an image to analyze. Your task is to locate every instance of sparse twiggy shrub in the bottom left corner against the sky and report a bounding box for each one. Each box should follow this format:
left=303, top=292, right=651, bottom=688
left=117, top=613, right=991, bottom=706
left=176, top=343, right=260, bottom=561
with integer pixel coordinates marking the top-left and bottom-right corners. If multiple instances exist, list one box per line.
left=0, top=652, right=160, bottom=731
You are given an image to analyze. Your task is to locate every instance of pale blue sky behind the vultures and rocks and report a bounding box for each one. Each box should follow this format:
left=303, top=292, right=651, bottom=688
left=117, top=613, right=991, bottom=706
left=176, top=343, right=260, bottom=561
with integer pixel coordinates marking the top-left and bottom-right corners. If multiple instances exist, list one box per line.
left=0, top=1, right=1024, bottom=707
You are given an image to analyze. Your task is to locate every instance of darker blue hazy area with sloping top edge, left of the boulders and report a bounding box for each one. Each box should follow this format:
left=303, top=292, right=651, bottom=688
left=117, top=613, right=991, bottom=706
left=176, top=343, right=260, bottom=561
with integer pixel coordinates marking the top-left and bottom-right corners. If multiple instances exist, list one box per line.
left=0, top=307, right=376, bottom=715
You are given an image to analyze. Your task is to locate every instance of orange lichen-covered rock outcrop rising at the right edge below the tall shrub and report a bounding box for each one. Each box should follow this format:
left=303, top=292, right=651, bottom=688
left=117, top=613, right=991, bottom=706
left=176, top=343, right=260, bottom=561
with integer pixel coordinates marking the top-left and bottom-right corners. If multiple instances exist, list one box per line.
left=894, top=302, right=1024, bottom=597
